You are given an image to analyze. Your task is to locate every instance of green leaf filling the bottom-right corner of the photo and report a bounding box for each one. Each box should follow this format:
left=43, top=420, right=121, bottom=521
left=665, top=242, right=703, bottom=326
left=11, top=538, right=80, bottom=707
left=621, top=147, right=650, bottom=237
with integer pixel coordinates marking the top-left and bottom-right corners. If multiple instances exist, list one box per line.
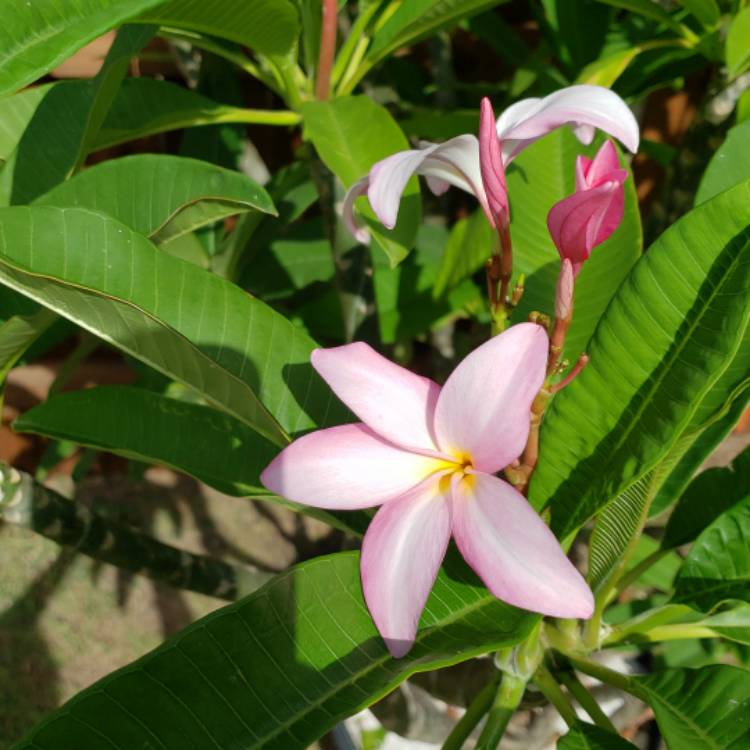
left=634, top=665, right=750, bottom=750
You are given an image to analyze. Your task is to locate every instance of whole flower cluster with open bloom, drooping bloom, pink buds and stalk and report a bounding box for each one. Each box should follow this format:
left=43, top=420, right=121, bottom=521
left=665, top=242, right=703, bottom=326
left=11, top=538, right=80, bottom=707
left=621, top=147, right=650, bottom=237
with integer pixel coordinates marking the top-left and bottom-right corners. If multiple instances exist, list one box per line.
left=262, top=86, right=638, bottom=657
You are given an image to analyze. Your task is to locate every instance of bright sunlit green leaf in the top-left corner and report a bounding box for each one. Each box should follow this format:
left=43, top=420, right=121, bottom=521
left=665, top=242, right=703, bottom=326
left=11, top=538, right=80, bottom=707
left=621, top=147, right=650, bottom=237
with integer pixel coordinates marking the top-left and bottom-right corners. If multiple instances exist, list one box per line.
left=0, top=0, right=163, bottom=94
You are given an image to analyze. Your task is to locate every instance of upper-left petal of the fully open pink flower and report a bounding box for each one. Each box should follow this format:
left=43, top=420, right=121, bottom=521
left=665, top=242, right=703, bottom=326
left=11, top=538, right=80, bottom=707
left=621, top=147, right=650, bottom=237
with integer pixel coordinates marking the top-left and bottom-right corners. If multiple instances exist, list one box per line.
left=311, top=342, right=440, bottom=451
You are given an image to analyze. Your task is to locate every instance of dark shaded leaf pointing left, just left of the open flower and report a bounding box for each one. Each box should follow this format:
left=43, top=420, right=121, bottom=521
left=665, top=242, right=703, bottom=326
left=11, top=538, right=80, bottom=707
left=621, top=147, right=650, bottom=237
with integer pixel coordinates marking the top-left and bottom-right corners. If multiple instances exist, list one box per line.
left=13, top=386, right=278, bottom=496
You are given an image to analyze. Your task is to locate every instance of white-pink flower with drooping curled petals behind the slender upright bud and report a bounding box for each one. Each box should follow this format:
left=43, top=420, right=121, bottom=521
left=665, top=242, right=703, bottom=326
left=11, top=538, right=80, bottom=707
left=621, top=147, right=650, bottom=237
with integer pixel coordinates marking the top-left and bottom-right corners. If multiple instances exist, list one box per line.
left=342, top=85, right=639, bottom=242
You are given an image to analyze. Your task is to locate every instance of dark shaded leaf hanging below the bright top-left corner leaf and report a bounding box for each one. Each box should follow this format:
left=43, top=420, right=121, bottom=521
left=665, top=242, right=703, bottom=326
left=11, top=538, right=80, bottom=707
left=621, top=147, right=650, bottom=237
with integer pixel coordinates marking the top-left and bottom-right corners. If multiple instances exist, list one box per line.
left=0, top=26, right=154, bottom=204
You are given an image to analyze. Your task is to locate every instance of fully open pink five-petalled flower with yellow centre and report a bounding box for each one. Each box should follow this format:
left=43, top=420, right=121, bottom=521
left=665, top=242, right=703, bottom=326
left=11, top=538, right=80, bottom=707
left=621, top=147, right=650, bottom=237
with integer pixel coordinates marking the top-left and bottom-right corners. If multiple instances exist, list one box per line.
left=261, top=323, right=593, bottom=658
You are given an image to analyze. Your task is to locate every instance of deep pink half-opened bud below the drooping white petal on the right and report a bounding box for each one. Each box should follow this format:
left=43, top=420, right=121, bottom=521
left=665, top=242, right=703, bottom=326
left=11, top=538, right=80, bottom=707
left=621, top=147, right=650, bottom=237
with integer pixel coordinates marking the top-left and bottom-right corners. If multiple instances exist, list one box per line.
left=547, top=141, right=628, bottom=274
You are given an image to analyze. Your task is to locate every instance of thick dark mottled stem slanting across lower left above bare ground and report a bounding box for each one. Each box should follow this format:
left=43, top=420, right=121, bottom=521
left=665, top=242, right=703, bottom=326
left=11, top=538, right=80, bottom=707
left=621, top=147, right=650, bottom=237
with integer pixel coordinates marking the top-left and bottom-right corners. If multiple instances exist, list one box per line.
left=0, top=462, right=272, bottom=601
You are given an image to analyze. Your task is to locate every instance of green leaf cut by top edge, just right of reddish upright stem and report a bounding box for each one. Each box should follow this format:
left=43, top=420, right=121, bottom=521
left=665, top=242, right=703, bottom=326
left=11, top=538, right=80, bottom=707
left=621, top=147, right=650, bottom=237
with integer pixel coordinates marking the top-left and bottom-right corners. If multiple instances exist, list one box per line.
left=366, top=0, right=506, bottom=64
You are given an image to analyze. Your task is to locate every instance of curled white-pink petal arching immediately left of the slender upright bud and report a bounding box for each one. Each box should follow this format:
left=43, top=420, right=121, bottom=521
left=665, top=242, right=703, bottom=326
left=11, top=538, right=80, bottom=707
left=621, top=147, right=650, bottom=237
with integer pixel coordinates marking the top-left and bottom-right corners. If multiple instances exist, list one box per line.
left=367, top=134, right=487, bottom=229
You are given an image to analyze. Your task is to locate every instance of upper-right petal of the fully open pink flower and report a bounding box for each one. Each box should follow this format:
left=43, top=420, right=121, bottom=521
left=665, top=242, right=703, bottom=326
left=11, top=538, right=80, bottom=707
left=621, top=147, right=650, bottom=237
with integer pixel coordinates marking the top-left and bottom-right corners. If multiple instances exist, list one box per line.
left=435, top=323, right=549, bottom=473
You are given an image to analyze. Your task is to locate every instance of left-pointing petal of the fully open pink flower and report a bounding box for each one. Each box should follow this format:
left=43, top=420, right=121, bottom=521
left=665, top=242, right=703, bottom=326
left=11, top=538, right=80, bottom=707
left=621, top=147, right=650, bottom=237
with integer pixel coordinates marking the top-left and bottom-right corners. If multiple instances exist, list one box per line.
left=260, top=424, right=445, bottom=510
